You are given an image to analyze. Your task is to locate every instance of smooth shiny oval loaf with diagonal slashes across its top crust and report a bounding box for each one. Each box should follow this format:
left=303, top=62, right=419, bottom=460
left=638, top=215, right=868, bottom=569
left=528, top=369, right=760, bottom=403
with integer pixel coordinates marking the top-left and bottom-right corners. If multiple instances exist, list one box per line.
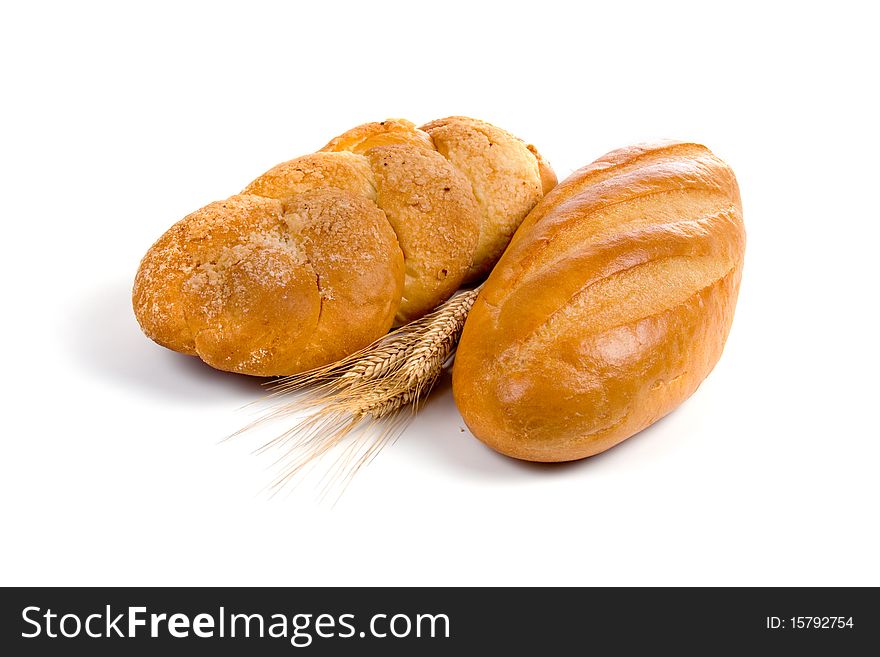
left=453, top=142, right=745, bottom=461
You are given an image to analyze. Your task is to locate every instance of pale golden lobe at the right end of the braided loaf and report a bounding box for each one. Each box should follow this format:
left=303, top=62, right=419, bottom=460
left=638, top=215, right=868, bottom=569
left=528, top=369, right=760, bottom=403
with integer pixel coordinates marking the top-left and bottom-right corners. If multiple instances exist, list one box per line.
left=421, top=116, right=549, bottom=280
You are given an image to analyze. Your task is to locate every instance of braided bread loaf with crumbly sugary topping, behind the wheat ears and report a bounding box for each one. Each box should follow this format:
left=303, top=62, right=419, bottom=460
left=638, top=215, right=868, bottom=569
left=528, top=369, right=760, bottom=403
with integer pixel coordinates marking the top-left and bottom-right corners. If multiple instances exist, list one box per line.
left=132, top=117, right=556, bottom=376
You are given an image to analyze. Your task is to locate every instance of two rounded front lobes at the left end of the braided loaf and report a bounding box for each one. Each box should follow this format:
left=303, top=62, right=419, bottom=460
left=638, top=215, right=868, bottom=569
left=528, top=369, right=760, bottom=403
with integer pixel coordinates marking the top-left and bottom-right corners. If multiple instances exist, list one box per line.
left=134, top=189, right=403, bottom=376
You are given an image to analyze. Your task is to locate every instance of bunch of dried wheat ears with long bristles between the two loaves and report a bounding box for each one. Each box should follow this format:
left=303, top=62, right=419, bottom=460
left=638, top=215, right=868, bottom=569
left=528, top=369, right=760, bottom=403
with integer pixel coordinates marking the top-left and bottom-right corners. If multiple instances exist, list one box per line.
left=237, top=288, right=480, bottom=495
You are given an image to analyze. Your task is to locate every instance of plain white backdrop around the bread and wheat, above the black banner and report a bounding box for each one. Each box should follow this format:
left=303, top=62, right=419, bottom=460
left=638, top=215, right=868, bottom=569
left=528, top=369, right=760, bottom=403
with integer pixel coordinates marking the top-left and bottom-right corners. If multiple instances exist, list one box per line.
left=0, top=1, right=880, bottom=585
